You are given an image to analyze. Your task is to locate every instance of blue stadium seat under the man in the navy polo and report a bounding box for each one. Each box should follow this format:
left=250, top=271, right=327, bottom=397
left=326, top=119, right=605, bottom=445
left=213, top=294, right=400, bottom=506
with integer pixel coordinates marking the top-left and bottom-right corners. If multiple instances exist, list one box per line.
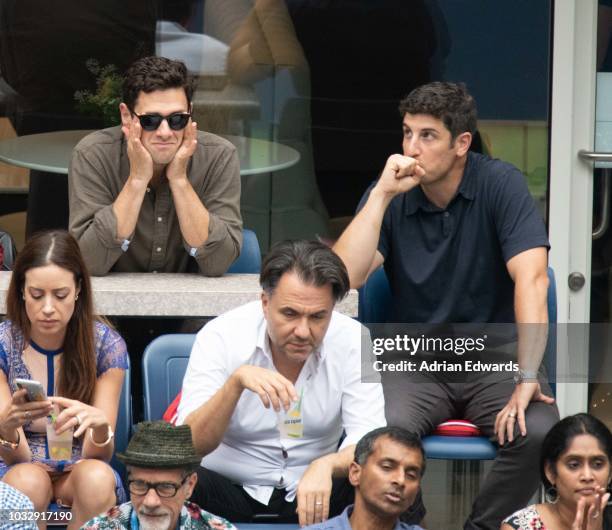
left=358, top=267, right=557, bottom=460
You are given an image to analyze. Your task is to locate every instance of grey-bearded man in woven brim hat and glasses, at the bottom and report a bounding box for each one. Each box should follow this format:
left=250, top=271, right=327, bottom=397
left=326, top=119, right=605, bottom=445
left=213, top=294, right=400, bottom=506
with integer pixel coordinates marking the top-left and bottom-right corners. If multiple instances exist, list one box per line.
left=82, top=421, right=236, bottom=530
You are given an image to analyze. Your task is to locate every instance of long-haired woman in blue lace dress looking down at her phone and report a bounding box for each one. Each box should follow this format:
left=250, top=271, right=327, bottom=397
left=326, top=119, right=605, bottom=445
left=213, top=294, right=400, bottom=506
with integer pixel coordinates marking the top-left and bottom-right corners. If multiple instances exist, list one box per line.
left=0, top=231, right=127, bottom=528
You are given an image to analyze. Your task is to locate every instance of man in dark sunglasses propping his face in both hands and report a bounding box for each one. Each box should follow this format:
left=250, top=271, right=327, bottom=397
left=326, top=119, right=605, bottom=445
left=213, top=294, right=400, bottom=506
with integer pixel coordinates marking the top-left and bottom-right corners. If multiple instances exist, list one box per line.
left=69, top=57, right=242, bottom=276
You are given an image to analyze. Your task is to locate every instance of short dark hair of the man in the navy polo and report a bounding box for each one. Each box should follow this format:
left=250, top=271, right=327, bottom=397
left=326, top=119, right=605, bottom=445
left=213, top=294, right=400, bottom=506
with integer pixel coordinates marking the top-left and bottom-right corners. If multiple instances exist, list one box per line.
left=399, top=81, right=477, bottom=142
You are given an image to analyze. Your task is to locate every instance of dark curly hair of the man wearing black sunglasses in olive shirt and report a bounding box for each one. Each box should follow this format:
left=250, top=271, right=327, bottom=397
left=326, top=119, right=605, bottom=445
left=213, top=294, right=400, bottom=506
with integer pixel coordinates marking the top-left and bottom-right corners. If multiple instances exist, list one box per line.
left=122, top=57, right=194, bottom=111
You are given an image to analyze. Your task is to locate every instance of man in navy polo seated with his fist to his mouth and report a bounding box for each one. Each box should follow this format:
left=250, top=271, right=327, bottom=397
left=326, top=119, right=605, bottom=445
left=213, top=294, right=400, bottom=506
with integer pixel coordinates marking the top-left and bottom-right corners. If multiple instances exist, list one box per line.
left=334, top=82, right=558, bottom=530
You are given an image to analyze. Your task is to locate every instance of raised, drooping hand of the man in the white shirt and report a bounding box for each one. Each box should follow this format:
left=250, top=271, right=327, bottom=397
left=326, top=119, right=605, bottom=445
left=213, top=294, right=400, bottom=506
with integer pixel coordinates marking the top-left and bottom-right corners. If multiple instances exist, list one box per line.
left=234, top=364, right=298, bottom=412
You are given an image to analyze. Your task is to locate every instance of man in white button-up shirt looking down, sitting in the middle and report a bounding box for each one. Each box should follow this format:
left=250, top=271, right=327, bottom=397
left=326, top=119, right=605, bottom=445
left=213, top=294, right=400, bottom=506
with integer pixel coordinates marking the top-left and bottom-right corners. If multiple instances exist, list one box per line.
left=178, top=241, right=385, bottom=525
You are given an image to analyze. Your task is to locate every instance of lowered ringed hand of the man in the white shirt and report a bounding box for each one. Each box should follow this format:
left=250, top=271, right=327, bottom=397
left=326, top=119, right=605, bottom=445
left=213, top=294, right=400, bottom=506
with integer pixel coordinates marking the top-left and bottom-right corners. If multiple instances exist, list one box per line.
left=297, top=460, right=332, bottom=526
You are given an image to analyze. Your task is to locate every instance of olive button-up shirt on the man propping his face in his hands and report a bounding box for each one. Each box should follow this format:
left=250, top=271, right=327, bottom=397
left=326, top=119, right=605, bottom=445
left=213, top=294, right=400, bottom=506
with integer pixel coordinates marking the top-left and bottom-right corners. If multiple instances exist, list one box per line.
left=68, top=127, right=242, bottom=276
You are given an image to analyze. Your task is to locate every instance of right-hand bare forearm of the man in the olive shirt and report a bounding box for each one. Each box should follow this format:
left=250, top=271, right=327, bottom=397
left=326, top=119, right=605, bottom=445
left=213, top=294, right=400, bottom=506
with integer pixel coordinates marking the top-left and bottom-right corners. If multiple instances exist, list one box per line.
left=169, top=178, right=210, bottom=248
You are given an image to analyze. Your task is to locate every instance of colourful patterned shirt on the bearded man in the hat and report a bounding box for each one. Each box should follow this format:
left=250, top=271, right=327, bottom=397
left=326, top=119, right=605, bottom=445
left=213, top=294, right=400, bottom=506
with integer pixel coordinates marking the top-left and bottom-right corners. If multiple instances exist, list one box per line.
left=81, top=502, right=238, bottom=530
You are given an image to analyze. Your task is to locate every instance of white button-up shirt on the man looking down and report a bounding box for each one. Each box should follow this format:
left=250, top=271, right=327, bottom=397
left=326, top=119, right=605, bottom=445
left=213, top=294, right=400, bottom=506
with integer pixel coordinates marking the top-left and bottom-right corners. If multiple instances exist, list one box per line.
left=177, top=302, right=386, bottom=505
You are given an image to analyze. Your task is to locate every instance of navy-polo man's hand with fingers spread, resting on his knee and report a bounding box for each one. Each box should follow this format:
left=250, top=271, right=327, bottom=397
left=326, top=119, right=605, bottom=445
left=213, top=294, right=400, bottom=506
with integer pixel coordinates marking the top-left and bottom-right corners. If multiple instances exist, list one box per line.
left=495, top=381, right=555, bottom=445
